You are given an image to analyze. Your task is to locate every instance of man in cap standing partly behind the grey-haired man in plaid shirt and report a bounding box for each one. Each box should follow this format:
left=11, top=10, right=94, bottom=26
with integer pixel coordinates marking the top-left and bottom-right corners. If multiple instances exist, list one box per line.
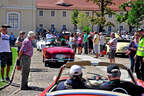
left=16, top=31, right=25, bottom=54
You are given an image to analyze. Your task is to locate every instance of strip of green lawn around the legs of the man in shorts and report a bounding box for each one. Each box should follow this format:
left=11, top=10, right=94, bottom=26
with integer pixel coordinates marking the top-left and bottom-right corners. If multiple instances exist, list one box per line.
left=0, top=48, right=17, bottom=87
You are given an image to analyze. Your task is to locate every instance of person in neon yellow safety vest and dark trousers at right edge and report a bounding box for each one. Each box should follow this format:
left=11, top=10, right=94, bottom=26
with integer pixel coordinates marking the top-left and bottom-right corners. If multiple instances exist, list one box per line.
left=135, top=29, right=144, bottom=81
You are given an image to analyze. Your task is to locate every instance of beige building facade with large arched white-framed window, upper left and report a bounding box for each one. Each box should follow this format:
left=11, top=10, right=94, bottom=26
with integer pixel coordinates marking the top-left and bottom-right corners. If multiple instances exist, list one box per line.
left=0, top=0, right=36, bottom=36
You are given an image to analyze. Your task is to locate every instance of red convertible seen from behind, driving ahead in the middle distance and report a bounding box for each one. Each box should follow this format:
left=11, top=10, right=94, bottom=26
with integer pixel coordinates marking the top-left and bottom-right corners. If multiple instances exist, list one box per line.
left=43, top=46, right=75, bottom=66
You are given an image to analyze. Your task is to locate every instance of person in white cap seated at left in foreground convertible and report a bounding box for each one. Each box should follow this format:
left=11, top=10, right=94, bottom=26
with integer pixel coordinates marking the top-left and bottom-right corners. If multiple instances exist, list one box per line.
left=57, top=65, right=87, bottom=90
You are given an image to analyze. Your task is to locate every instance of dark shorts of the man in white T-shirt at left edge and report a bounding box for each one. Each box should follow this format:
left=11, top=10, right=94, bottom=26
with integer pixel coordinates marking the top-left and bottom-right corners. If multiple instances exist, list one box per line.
left=0, top=52, right=12, bottom=67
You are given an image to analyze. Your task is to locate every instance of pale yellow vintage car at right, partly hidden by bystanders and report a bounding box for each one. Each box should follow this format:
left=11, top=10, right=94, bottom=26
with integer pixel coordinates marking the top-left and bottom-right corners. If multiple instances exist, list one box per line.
left=106, top=40, right=130, bottom=55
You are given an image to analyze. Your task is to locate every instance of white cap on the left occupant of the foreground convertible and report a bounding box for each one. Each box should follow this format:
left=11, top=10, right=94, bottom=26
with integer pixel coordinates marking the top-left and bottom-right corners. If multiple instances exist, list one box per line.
left=70, top=65, right=82, bottom=75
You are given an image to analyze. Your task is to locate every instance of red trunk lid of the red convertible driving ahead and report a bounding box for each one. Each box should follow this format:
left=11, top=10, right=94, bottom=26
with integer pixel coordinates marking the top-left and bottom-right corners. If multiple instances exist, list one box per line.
left=45, top=47, right=74, bottom=54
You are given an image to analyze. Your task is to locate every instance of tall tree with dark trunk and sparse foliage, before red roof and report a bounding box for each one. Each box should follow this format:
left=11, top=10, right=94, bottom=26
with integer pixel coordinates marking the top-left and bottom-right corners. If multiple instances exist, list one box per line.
left=87, top=0, right=114, bottom=32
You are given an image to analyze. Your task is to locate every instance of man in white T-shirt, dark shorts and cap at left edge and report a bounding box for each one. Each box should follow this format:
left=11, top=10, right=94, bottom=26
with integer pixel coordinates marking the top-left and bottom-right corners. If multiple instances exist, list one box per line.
left=0, top=24, right=12, bottom=82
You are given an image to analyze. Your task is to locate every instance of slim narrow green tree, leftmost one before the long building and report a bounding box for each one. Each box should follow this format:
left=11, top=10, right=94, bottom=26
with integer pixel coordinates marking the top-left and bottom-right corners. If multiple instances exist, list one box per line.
left=72, top=9, right=79, bottom=31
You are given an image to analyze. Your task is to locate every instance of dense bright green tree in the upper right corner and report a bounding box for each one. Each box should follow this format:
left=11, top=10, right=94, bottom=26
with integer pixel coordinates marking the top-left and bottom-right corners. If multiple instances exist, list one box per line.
left=116, top=0, right=144, bottom=32
